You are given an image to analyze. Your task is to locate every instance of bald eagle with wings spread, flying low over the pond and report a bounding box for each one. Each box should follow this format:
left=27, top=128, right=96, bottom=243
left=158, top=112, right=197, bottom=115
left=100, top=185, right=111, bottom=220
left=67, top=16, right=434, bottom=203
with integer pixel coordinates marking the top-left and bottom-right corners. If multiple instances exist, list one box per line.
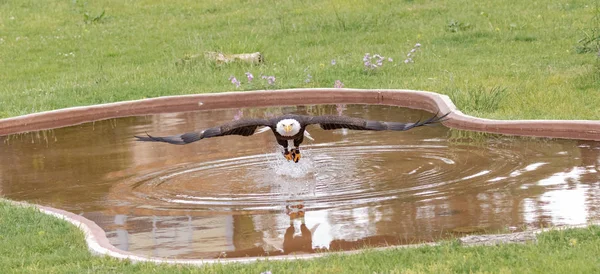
left=134, top=113, right=450, bottom=163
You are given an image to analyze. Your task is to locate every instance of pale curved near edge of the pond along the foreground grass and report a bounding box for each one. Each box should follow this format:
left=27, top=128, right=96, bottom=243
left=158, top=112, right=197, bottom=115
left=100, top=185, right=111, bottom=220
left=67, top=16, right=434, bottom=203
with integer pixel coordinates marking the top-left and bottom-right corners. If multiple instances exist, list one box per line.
left=5, top=198, right=600, bottom=266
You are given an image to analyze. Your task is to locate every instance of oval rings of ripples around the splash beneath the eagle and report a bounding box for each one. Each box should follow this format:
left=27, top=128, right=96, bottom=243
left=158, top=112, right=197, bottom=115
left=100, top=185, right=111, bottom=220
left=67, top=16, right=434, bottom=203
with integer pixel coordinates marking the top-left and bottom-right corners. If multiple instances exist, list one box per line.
left=111, top=142, right=535, bottom=214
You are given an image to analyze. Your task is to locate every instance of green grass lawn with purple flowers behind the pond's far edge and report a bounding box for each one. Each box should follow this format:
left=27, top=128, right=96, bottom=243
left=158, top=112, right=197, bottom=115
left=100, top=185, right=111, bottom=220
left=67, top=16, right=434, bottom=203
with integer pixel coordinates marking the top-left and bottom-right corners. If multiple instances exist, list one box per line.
left=0, top=0, right=600, bottom=119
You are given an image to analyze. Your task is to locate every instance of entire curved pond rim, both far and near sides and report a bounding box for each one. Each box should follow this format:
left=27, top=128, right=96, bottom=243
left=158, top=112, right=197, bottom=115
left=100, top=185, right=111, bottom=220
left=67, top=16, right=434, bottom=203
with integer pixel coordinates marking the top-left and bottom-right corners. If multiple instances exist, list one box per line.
left=0, top=88, right=600, bottom=265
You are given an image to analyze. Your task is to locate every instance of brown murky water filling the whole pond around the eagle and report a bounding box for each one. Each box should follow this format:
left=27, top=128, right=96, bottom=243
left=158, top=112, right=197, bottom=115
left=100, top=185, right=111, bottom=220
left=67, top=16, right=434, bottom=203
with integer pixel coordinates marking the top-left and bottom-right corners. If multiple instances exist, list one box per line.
left=0, top=105, right=600, bottom=258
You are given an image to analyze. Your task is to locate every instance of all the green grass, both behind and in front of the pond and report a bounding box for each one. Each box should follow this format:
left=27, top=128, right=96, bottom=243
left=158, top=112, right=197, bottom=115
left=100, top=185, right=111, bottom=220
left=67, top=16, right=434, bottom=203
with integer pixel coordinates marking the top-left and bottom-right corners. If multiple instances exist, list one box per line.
left=0, top=0, right=600, bottom=273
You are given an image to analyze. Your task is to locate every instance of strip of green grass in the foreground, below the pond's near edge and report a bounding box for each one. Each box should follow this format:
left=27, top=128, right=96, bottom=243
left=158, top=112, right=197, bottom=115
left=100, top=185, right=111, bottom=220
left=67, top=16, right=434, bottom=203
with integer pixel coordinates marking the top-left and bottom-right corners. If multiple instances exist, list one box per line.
left=0, top=201, right=600, bottom=273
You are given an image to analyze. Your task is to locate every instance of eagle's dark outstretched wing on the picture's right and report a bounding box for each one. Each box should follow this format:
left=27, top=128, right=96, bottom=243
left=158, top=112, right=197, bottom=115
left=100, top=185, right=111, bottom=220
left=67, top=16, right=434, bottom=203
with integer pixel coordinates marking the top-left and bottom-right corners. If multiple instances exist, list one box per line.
left=305, top=113, right=450, bottom=131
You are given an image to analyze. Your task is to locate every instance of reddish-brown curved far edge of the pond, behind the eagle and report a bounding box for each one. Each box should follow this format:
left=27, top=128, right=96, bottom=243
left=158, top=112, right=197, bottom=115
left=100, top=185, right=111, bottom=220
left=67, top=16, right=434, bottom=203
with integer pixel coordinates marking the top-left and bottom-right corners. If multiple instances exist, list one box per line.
left=0, top=88, right=600, bottom=141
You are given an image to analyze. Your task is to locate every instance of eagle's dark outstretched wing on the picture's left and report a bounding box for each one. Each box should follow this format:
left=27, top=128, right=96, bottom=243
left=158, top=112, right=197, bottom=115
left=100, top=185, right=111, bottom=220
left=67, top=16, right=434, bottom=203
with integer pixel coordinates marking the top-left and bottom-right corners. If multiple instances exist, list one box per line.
left=134, top=119, right=271, bottom=145
